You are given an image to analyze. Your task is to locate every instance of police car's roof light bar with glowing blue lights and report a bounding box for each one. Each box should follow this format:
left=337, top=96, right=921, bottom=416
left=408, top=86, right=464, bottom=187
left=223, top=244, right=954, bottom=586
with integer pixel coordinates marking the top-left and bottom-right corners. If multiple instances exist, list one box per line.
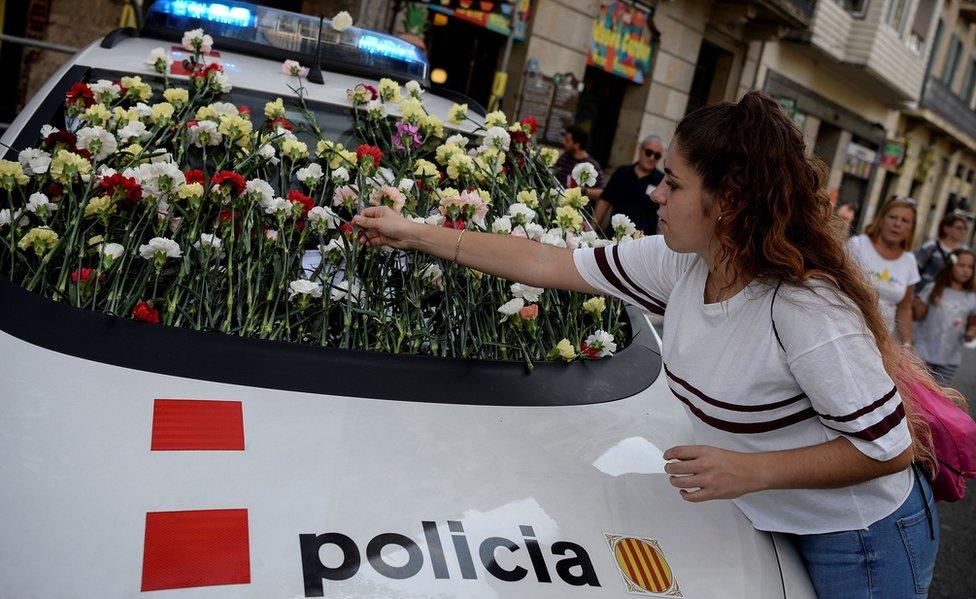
left=144, top=0, right=430, bottom=82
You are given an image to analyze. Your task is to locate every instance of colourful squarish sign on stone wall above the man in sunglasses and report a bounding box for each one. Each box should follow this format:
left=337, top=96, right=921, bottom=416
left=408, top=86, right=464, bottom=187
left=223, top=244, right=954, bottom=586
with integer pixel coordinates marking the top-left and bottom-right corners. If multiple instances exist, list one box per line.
left=586, top=2, right=652, bottom=83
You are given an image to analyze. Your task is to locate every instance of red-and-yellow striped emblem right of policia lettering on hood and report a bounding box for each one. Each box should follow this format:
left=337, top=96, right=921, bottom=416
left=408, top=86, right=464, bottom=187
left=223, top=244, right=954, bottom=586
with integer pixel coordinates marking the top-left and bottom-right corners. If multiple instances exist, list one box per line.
left=606, top=534, right=684, bottom=598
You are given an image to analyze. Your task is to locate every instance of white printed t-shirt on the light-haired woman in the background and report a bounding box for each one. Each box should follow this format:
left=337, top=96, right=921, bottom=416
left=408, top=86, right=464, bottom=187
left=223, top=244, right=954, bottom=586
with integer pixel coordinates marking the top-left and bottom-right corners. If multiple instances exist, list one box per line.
left=847, top=234, right=922, bottom=331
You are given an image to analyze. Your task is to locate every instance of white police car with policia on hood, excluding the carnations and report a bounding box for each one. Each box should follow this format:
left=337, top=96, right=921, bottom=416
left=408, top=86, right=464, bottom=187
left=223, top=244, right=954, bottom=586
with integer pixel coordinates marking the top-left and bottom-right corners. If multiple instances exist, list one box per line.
left=0, top=0, right=814, bottom=599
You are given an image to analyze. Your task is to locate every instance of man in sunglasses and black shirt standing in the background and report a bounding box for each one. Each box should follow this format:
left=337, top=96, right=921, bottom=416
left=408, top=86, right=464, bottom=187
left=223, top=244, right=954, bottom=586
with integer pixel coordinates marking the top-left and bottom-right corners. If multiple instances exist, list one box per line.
left=593, top=135, right=664, bottom=235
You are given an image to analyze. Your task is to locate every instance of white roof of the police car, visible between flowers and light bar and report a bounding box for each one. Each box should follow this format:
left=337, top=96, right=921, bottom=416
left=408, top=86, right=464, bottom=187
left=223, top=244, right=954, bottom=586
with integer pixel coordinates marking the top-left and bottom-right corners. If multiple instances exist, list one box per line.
left=72, top=37, right=484, bottom=134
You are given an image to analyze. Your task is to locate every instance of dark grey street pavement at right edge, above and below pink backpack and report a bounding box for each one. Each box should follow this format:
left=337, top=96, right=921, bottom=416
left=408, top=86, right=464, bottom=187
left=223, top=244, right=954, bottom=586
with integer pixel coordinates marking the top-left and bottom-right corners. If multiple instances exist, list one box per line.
left=929, top=349, right=976, bottom=599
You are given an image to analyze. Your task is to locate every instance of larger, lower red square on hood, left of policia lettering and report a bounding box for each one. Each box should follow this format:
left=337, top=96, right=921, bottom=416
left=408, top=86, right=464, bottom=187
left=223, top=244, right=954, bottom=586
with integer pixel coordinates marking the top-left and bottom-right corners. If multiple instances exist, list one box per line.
left=142, top=509, right=251, bottom=591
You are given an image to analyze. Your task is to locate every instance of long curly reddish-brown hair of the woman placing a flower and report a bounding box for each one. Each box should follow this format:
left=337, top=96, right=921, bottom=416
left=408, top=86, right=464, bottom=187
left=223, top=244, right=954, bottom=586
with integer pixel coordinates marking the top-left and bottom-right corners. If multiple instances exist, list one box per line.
left=674, top=91, right=965, bottom=471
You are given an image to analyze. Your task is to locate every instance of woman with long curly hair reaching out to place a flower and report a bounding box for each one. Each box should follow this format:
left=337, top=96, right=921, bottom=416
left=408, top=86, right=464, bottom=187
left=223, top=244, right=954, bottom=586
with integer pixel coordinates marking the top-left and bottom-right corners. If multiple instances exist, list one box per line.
left=356, top=92, right=939, bottom=599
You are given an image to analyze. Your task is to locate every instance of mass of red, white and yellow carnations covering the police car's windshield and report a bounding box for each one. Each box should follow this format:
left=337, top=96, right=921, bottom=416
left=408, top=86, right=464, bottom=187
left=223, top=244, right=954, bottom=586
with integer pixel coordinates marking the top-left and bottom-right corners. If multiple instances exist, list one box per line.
left=0, top=30, right=648, bottom=364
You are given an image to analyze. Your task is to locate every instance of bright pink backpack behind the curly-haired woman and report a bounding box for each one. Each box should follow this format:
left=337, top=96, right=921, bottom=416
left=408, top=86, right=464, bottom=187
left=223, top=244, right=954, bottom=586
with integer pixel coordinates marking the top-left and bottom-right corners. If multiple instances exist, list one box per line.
left=911, top=383, right=976, bottom=501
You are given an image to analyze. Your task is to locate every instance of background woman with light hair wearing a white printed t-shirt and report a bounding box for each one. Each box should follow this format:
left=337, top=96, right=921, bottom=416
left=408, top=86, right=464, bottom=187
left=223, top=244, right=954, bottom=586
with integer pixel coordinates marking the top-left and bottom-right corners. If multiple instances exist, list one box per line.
left=847, top=198, right=919, bottom=346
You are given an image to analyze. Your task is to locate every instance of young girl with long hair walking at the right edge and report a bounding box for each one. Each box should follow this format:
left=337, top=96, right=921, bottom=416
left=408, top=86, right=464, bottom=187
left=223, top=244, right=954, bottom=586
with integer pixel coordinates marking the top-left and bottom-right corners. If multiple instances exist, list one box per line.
left=913, top=249, right=976, bottom=386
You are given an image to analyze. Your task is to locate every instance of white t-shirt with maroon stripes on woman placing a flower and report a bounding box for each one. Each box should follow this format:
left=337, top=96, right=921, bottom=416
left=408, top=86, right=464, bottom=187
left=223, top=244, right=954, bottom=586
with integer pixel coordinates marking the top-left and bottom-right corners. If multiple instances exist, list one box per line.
left=574, top=235, right=912, bottom=534
